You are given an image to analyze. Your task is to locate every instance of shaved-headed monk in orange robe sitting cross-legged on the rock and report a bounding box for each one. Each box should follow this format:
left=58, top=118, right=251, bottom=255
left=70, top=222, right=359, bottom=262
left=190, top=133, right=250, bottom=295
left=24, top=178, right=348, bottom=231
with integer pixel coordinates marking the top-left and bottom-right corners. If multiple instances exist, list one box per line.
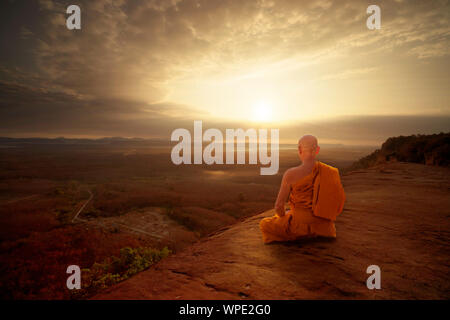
left=260, top=135, right=345, bottom=243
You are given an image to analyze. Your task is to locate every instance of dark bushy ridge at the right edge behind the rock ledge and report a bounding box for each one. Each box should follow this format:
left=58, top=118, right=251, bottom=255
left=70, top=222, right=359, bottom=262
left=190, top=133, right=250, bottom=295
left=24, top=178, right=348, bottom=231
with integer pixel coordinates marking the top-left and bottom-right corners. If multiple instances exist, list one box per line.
left=350, top=132, right=450, bottom=169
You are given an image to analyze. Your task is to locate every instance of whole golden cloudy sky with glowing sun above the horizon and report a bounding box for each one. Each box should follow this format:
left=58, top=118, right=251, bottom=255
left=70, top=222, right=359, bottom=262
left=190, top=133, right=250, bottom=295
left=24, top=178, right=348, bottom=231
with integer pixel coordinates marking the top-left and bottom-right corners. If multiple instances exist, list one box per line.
left=0, top=0, right=450, bottom=144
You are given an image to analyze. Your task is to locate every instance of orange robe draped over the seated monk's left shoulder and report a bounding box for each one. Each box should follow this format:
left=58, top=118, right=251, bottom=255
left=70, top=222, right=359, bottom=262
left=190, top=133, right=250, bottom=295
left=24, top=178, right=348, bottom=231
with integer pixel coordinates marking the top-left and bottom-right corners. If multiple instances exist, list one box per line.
left=259, top=161, right=345, bottom=243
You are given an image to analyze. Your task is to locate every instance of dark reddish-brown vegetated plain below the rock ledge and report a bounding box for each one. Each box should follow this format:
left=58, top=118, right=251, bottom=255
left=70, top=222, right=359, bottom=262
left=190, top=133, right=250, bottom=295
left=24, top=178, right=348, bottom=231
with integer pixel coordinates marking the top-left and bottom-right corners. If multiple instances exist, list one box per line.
left=0, top=143, right=367, bottom=299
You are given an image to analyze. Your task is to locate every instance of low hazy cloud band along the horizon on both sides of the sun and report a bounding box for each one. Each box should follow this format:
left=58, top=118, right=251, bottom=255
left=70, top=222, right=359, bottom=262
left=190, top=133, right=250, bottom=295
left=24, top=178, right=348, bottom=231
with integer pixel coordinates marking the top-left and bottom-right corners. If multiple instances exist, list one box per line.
left=0, top=78, right=450, bottom=145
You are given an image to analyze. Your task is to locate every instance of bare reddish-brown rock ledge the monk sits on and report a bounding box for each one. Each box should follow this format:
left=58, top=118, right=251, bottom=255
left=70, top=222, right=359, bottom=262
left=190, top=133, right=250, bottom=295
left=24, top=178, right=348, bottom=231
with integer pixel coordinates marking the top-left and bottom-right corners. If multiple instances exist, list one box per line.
left=95, top=163, right=450, bottom=299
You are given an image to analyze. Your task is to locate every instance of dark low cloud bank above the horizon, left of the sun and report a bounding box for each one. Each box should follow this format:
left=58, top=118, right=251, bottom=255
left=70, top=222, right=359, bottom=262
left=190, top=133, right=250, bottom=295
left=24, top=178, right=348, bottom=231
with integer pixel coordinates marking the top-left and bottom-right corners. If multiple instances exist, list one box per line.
left=0, top=82, right=204, bottom=137
